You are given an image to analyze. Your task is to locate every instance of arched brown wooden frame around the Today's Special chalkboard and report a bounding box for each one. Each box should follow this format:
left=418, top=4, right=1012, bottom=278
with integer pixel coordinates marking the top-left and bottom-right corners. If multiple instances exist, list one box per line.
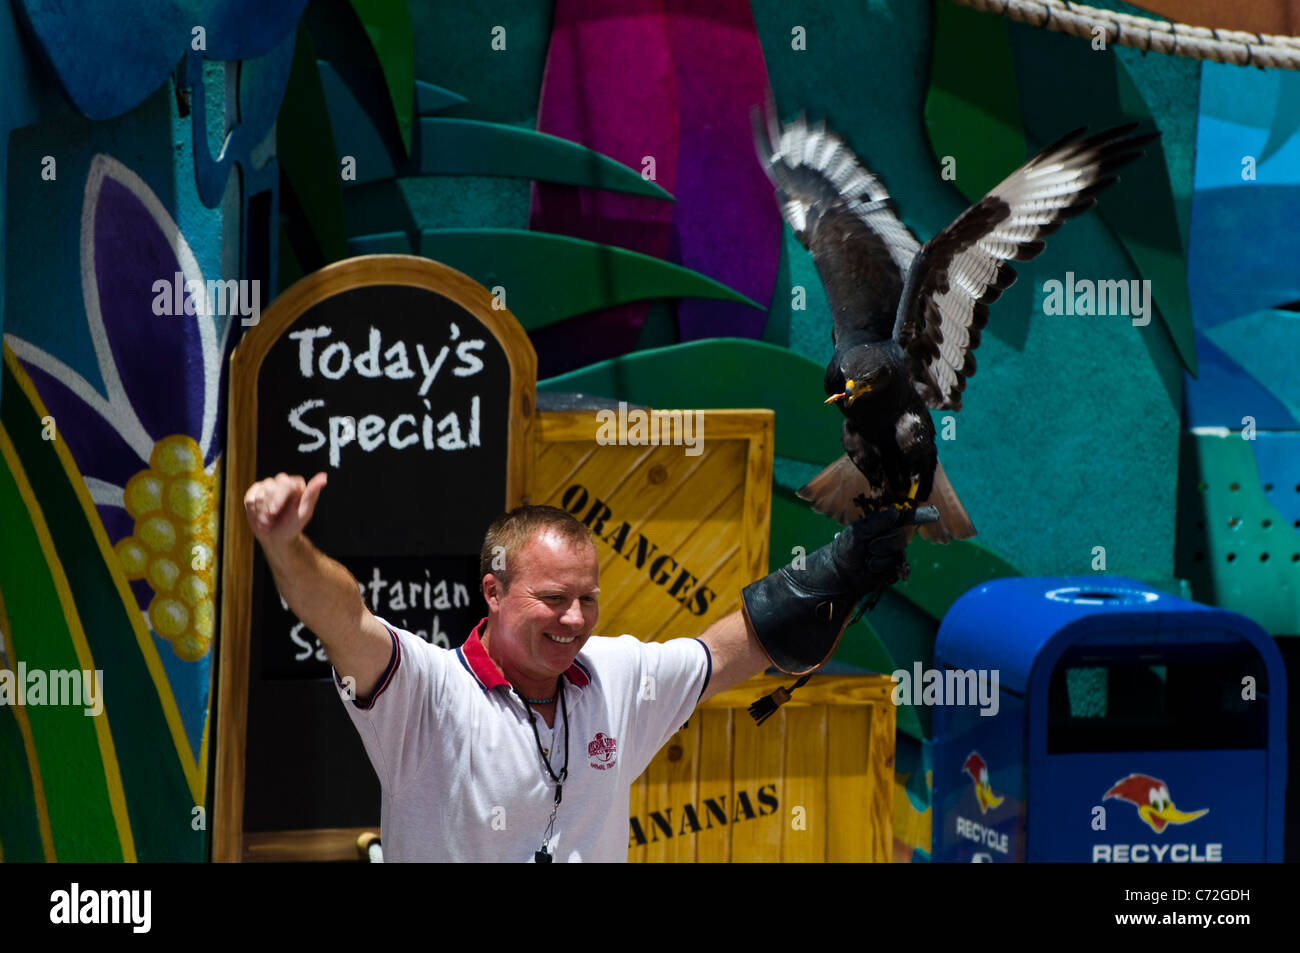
left=212, top=255, right=537, bottom=862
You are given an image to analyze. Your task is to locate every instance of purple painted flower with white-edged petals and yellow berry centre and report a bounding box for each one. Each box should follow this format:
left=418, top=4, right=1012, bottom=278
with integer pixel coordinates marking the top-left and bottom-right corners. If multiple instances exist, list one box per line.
left=5, top=155, right=230, bottom=662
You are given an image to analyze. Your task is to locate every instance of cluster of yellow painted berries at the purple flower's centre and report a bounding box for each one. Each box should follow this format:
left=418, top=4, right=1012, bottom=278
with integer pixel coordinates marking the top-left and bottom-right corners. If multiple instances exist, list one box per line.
left=113, top=434, right=220, bottom=662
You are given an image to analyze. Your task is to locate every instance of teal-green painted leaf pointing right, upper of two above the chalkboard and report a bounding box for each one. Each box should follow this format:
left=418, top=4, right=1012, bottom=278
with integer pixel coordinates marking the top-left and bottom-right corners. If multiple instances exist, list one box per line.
left=417, top=116, right=672, bottom=199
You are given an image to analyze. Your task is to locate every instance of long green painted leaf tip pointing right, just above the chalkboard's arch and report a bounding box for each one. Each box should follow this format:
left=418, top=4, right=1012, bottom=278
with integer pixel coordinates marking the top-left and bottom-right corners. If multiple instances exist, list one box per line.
left=420, top=229, right=762, bottom=330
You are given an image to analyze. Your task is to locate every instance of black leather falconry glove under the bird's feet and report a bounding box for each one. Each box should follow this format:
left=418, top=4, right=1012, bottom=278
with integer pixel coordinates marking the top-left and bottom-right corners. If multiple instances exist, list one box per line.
left=741, top=506, right=939, bottom=724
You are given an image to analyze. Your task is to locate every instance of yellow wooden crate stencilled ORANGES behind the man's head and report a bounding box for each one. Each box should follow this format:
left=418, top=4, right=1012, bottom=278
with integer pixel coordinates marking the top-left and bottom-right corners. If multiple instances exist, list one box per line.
left=529, top=410, right=775, bottom=641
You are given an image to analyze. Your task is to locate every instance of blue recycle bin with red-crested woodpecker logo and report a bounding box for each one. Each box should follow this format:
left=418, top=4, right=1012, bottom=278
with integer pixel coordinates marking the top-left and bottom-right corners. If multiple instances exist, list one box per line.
left=931, top=577, right=1287, bottom=863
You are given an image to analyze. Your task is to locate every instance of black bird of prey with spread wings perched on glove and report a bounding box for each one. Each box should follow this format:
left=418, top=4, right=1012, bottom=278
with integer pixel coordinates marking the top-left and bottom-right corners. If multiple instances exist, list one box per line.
left=754, top=101, right=1157, bottom=542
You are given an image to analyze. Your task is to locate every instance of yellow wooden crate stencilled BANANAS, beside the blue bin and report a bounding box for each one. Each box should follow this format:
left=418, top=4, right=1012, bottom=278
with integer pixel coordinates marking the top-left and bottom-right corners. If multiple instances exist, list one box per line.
left=628, top=675, right=896, bottom=863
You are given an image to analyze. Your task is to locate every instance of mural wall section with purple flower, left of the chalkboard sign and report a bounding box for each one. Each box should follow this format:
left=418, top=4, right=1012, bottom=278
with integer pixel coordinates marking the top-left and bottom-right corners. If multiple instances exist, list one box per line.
left=0, top=1, right=302, bottom=861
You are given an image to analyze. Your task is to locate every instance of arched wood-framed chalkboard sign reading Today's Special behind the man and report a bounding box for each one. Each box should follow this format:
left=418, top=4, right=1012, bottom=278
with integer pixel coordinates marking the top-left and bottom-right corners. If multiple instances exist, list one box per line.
left=213, top=255, right=537, bottom=861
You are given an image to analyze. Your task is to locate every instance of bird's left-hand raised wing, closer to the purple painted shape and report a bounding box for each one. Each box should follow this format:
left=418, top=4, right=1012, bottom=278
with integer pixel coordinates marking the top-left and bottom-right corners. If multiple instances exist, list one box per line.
left=753, top=100, right=920, bottom=347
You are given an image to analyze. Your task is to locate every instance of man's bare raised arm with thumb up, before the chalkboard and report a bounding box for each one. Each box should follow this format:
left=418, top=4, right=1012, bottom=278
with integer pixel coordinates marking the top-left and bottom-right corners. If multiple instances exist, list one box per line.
left=244, top=473, right=393, bottom=697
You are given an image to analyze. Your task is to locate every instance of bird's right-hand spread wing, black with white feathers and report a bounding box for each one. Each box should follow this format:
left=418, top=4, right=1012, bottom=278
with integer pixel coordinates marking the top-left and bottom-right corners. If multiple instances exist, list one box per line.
left=893, top=124, right=1156, bottom=410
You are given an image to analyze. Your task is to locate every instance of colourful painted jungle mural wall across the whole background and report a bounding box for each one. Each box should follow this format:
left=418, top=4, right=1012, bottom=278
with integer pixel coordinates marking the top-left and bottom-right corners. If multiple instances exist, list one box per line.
left=0, top=0, right=1300, bottom=859
